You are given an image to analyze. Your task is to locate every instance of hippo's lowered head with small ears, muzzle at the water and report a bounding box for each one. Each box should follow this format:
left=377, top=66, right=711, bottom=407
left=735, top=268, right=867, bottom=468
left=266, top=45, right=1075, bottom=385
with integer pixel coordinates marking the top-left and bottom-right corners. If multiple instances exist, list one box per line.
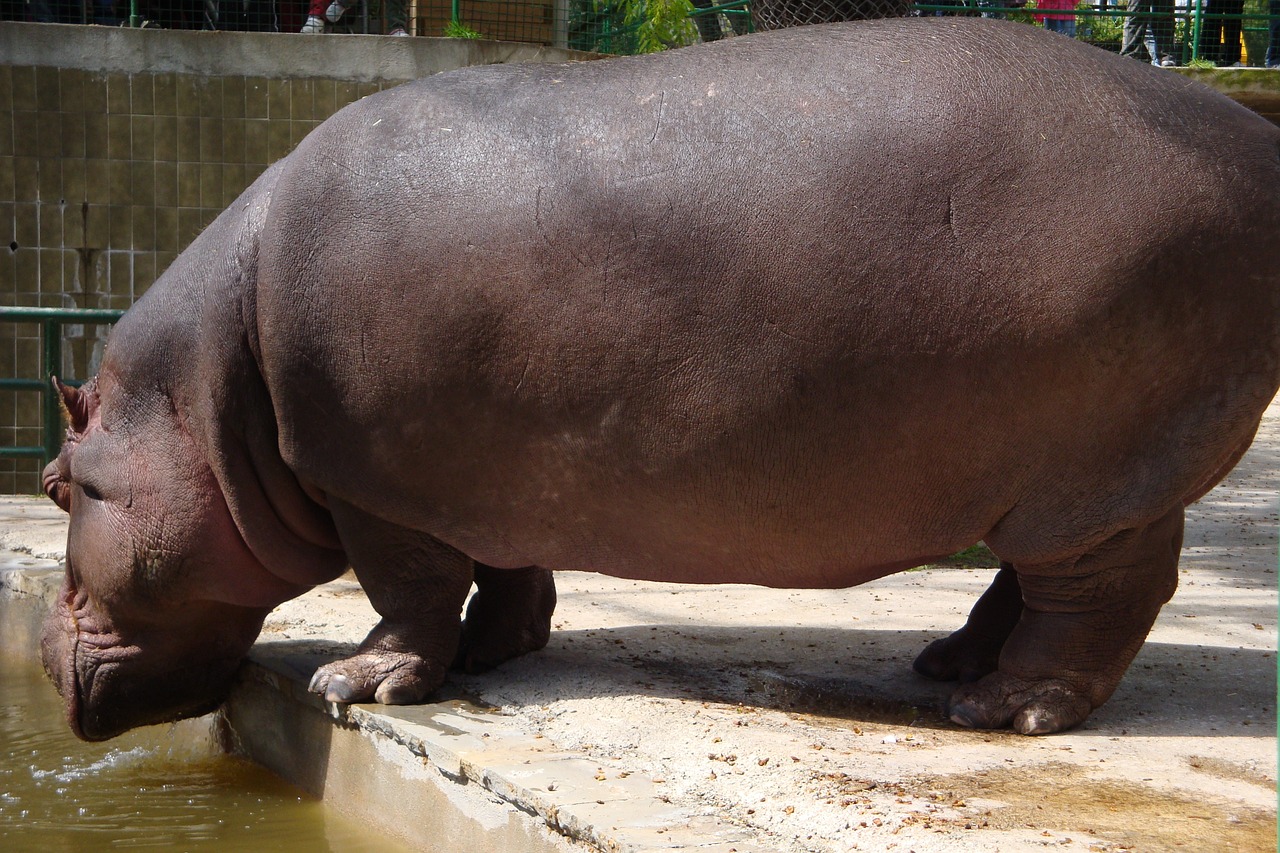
left=41, top=369, right=301, bottom=740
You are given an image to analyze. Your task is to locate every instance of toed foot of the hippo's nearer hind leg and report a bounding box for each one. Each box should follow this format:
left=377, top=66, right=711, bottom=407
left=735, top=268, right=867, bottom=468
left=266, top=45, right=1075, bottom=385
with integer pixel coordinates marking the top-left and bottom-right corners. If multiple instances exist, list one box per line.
left=952, top=671, right=1093, bottom=735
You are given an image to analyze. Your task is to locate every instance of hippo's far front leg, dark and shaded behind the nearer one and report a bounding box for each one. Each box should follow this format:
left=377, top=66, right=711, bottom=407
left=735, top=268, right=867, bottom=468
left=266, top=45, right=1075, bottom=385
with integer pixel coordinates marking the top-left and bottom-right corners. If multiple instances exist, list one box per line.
left=453, top=564, right=556, bottom=672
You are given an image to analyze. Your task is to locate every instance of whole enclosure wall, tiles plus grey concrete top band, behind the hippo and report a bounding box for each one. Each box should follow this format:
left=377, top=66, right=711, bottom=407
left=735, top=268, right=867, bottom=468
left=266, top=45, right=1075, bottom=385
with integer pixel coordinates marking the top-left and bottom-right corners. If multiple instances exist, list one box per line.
left=0, top=22, right=588, bottom=493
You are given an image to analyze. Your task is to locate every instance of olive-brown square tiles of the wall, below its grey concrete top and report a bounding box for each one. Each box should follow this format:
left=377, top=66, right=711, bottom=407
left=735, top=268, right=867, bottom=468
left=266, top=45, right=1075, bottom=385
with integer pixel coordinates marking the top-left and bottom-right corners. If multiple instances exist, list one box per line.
left=0, top=65, right=384, bottom=493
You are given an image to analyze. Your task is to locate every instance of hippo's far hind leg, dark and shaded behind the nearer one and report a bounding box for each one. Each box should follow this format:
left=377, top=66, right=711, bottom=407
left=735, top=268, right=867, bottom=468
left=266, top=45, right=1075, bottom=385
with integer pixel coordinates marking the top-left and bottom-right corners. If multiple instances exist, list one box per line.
left=914, top=562, right=1023, bottom=683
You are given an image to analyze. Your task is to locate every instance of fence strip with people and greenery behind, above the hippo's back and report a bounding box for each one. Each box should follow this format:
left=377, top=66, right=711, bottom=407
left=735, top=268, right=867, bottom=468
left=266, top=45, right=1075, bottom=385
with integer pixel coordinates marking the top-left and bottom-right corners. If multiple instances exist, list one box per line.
left=0, top=0, right=1280, bottom=67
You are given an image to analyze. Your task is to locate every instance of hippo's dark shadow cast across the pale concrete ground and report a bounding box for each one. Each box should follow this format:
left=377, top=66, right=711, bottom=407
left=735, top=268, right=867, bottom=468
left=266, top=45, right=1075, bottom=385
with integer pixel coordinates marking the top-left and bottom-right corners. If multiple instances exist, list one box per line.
left=255, top=625, right=1276, bottom=736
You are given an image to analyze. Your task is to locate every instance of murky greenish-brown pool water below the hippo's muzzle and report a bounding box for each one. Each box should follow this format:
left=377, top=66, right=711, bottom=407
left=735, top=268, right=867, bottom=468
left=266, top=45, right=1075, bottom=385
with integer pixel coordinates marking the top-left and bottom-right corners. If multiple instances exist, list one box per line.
left=0, top=598, right=406, bottom=853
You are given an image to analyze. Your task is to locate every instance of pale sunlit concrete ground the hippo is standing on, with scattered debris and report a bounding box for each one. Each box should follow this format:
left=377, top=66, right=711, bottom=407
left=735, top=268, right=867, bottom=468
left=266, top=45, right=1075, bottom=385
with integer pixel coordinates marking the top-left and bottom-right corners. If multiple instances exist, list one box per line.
left=0, top=400, right=1280, bottom=853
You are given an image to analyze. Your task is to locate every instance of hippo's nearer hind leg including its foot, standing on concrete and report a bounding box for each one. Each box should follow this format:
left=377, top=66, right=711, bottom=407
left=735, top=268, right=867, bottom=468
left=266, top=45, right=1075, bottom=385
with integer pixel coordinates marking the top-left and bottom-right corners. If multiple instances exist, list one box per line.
left=947, top=506, right=1183, bottom=734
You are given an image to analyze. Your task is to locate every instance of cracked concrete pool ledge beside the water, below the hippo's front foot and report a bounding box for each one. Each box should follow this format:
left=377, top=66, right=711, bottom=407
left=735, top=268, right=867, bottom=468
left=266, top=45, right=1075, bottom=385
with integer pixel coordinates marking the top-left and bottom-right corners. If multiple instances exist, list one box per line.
left=224, top=646, right=763, bottom=853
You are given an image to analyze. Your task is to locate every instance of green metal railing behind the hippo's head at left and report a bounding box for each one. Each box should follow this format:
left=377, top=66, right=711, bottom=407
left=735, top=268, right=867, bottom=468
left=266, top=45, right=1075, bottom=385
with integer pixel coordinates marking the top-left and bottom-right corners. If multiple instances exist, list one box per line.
left=0, top=307, right=124, bottom=462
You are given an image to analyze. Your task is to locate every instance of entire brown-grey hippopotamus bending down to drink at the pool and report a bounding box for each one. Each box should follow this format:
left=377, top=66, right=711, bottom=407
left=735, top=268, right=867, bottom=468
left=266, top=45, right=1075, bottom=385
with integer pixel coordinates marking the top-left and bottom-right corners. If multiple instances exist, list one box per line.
left=42, top=18, right=1280, bottom=739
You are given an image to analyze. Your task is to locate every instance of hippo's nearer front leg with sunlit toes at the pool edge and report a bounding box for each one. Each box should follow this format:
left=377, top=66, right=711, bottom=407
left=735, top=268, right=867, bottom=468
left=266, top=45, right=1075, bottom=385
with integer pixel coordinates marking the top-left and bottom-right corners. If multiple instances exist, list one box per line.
left=308, top=500, right=472, bottom=704
